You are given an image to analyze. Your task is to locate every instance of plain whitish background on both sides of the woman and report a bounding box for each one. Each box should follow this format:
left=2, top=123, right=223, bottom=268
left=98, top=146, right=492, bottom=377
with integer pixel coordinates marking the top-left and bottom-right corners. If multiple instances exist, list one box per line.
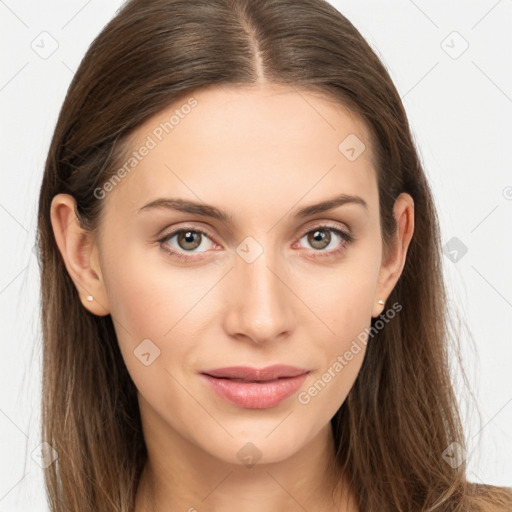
left=0, top=0, right=512, bottom=512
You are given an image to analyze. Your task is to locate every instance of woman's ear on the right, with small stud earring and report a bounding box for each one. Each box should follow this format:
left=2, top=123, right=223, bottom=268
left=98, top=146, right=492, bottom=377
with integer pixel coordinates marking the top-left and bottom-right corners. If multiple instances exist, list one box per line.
left=372, top=192, right=414, bottom=318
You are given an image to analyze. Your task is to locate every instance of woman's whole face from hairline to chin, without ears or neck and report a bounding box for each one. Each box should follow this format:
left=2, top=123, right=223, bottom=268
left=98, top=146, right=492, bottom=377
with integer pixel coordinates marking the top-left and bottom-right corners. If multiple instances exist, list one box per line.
left=78, top=85, right=396, bottom=464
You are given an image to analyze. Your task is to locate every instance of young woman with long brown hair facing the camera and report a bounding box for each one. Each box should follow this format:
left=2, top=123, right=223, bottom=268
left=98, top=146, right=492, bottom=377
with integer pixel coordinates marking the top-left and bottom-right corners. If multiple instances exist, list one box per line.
left=38, top=0, right=512, bottom=512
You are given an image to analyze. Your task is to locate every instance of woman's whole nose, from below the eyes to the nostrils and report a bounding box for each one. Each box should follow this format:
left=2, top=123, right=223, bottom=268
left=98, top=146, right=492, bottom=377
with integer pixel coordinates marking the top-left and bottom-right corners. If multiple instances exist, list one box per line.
left=224, top=246, right=299, bottom=345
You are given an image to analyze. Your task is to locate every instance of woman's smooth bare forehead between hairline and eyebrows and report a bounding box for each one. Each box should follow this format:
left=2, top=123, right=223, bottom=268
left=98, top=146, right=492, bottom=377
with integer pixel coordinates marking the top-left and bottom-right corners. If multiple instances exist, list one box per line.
left=108, top=84, right=376, bottom=220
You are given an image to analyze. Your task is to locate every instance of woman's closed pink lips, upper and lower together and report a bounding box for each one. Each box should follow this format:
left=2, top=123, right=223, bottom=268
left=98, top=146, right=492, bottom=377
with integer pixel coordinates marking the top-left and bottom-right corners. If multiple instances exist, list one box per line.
left=201, top=365, right=309, bottom=409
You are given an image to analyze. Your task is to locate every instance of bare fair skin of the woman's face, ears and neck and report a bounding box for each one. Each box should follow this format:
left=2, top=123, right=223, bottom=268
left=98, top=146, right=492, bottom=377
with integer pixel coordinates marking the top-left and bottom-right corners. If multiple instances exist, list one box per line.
left=51, top=84, right=414, bottom=512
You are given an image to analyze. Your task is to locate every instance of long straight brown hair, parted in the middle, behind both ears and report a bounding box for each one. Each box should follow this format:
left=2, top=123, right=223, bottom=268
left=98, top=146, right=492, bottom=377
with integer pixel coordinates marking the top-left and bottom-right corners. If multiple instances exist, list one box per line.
left=38, top=0, right=512, bottom=512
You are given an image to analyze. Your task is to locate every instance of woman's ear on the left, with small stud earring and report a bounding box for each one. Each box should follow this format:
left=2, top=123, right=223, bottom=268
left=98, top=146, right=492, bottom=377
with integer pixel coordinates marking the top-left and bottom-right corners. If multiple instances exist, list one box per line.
left=50, top=194, right=110, bottom=316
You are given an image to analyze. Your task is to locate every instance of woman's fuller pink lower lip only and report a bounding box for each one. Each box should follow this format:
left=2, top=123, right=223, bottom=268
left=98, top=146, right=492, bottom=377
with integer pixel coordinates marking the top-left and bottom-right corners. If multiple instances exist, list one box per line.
left=201, top=373, right=308, bottom=409
